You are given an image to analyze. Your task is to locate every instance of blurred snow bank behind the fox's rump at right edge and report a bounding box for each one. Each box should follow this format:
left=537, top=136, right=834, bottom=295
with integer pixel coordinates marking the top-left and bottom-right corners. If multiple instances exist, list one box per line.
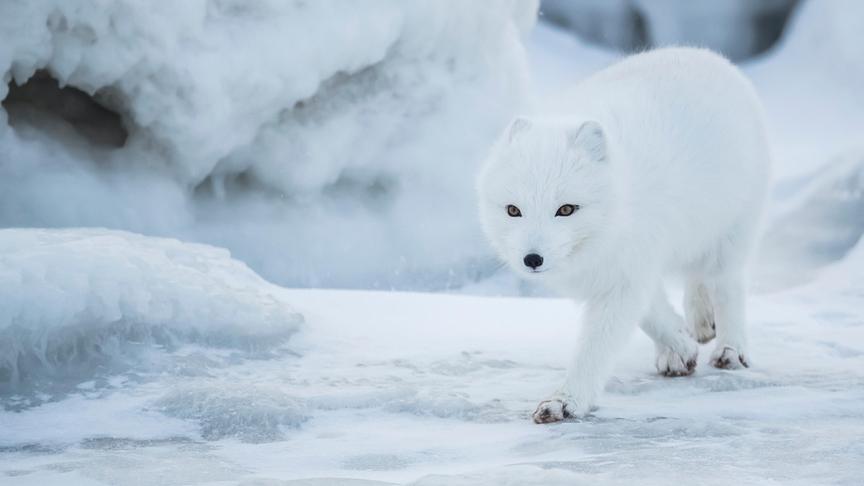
left=743, top=0, right=864, bottom=288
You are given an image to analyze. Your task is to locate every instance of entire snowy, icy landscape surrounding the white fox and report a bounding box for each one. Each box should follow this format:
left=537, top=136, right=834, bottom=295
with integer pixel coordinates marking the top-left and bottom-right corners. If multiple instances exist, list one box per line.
left=0, top=0, right=864, bottom=486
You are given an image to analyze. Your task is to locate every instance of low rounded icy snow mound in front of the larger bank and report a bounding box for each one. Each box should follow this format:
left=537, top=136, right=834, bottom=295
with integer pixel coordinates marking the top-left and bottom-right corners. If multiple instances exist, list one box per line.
left=0, top=229, right=301, bottom=400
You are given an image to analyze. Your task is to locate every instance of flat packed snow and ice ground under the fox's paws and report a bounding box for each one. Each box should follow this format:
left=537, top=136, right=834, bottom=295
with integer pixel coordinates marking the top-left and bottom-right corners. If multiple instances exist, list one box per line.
left=0, top=276, right=864, bottom=485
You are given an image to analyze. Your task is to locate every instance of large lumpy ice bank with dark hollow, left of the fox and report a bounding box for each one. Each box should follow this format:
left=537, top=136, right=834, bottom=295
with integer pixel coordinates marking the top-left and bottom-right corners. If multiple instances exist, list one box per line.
left=0, top=0, right=537, bottom=287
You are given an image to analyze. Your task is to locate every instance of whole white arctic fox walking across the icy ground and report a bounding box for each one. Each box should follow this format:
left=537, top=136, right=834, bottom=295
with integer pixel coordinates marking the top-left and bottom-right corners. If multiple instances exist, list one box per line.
left=478, top=48, right=770, bottom=423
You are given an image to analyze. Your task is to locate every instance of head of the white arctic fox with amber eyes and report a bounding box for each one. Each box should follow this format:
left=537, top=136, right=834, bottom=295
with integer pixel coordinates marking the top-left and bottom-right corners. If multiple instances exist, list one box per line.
left=478, top=118, right=612, bottom=278
